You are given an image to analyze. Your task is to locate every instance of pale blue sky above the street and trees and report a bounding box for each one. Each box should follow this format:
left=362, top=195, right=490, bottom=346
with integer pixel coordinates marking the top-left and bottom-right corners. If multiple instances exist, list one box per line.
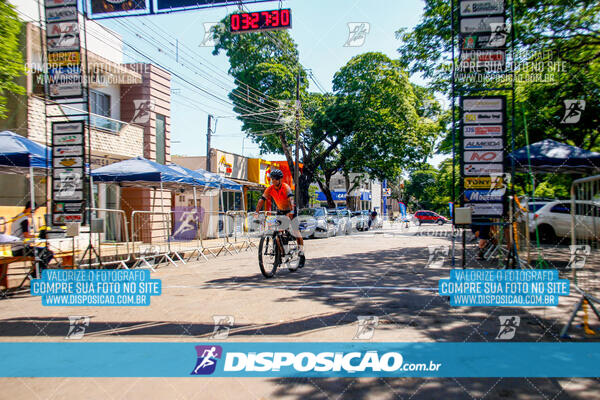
left=102, top=0, right=446, bottom=163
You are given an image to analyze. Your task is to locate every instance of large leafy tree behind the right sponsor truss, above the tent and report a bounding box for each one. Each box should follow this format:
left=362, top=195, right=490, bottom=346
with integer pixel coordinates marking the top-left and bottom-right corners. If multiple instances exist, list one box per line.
left=397, top=0, right=600, bottom=200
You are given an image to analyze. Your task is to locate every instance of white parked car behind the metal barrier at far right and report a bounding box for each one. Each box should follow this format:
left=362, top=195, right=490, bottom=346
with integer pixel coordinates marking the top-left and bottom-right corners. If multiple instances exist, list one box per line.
left=529, top=200, right=600, bottom=242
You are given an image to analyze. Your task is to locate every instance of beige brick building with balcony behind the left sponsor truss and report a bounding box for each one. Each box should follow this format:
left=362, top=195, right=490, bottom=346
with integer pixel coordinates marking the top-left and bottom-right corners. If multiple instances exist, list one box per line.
left=0, top=0, right=171, bottom=241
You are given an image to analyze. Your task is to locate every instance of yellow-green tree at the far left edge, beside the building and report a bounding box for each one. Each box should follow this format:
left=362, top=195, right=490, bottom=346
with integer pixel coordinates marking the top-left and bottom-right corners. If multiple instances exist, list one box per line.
left=0, top=0, right=25, bottom=118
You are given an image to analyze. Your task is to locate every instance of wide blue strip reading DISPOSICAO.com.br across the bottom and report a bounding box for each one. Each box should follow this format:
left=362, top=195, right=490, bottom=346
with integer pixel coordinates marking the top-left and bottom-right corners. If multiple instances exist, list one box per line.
left=0, top=342, right=600, bottom=379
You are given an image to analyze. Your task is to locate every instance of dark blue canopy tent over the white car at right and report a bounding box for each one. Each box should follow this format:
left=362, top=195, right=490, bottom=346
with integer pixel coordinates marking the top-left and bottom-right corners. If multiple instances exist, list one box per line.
left=508, top=139, right=600, bottom=173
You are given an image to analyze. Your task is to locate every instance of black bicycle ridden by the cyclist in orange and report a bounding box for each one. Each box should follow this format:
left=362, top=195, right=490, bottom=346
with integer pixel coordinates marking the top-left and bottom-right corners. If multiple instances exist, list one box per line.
left=253, top=212, right=305, bottom=279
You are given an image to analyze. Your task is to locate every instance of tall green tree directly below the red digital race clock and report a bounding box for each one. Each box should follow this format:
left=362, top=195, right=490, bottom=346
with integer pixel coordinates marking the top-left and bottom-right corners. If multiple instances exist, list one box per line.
left=213, top=17, right=308, bottom=175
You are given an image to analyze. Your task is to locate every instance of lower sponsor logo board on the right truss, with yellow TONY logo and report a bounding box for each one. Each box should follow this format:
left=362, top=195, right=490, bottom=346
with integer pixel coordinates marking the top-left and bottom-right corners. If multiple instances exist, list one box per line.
left=460, top=96, right=509, bottom=219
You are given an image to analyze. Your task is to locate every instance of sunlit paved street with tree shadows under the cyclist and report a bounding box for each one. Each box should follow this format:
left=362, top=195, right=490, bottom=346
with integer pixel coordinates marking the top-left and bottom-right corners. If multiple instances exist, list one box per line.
left=0, top=226, right=600, bottom=399
